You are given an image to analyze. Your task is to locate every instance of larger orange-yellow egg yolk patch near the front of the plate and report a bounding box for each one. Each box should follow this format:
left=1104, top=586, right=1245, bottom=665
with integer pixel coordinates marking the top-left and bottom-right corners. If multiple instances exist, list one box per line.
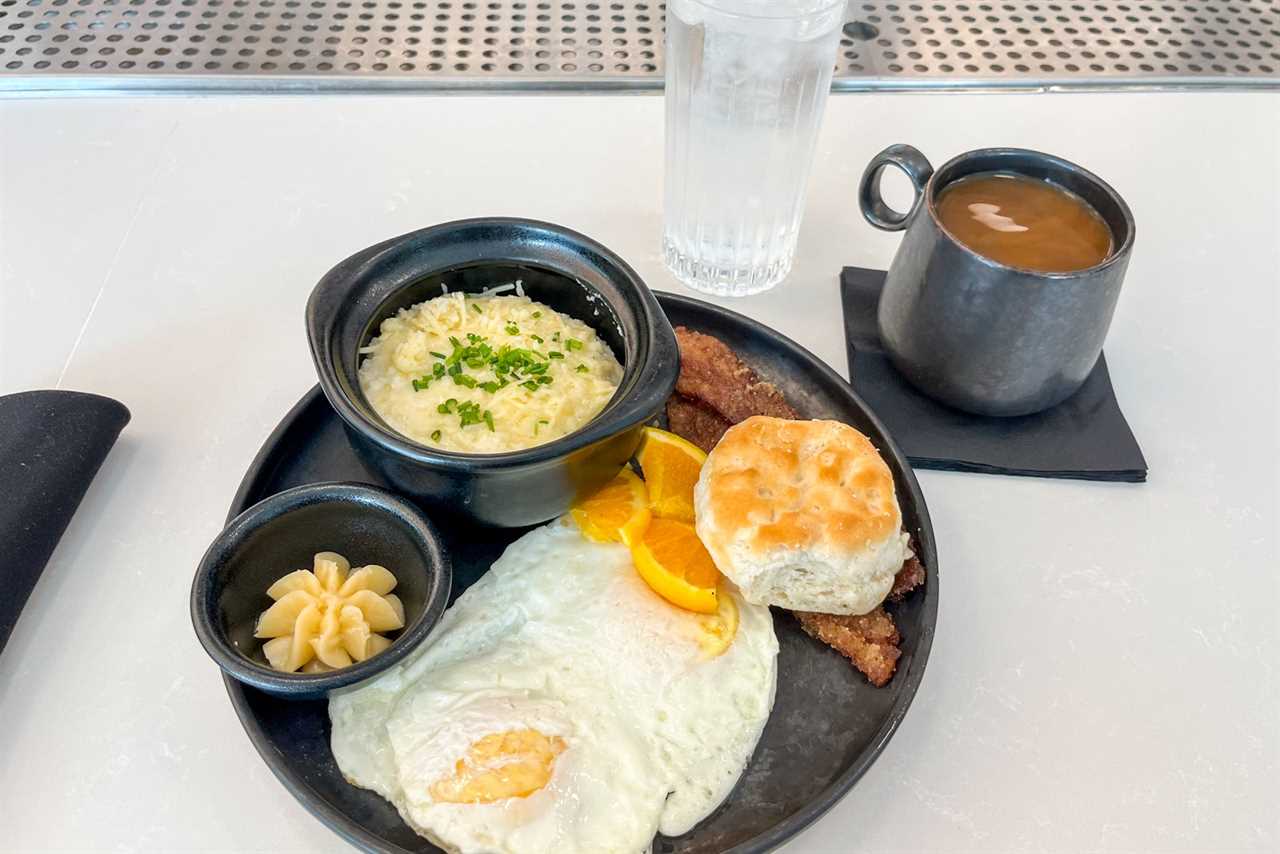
left=431, top=730, right=568, bottom=804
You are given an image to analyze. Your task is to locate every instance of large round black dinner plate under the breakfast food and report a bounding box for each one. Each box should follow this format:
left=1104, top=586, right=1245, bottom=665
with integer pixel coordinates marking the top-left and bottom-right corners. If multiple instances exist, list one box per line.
left=224, top=293, right=938, bottom=854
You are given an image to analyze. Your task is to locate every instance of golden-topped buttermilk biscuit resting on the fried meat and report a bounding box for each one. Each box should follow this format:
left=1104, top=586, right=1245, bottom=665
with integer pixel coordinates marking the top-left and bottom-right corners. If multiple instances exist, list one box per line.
left=694, top=416, right=911, bottom=615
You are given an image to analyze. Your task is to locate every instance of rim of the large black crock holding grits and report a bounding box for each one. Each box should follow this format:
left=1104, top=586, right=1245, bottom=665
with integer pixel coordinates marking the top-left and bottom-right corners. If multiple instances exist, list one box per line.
left=306, top=216, right=680, bottom=472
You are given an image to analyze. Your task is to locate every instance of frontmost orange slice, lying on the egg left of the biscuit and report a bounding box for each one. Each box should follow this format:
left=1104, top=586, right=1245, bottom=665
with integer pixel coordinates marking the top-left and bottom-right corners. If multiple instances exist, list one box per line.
left=630, top=519, right=719, bottom=613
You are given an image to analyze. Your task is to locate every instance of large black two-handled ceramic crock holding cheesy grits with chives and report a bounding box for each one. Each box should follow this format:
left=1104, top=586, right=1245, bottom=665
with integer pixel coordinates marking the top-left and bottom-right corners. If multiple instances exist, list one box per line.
left=307, top=218, right=680, bottom=528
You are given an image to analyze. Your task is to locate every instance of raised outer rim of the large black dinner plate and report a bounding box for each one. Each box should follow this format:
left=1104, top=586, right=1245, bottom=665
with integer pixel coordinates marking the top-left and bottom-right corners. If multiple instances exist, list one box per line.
left=223, top=291, right=938, bottom=854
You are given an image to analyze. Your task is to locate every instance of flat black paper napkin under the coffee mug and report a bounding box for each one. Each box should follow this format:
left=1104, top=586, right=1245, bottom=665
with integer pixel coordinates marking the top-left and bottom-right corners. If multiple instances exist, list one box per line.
left=840, top=266, right=1147, bottom=483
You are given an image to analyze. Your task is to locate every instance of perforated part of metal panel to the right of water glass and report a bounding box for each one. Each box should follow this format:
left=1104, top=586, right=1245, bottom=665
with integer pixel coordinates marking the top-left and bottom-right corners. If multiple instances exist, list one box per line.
left=836, top=0, right=1280, bottom=85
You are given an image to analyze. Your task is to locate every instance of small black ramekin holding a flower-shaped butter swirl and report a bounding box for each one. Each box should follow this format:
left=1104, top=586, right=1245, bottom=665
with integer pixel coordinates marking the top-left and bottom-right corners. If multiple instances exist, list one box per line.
left=191, top=483, right=453, bottom=699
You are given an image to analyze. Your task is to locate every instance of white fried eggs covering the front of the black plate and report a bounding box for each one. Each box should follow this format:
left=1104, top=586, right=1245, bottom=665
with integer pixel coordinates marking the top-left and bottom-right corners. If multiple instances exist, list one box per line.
left=329, top=521, right=778, bottom=854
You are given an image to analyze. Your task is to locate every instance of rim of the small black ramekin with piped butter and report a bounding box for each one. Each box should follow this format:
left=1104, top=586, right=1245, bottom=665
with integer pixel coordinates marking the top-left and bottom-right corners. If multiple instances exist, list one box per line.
left=191, top=480, right=453, bottom=699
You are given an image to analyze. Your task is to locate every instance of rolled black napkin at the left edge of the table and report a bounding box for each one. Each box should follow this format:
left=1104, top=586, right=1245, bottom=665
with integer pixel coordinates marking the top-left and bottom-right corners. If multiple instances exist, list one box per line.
left=0, top=391, right=129, bottom=652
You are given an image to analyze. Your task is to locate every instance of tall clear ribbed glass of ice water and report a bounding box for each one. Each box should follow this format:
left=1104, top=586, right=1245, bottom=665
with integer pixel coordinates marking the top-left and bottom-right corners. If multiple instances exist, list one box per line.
left=662, top=0, right=845, bottom=296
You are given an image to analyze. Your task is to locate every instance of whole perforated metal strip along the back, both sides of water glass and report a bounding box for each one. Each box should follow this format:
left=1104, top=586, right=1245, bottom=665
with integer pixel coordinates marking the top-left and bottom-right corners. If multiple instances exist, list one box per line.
left=0, top=0, right=1280, bottom=90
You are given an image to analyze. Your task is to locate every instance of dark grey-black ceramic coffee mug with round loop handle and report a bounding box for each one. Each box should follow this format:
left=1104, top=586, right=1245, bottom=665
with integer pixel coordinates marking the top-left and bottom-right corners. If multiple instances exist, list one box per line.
left=859, top=145, right=1134, bottom=415
